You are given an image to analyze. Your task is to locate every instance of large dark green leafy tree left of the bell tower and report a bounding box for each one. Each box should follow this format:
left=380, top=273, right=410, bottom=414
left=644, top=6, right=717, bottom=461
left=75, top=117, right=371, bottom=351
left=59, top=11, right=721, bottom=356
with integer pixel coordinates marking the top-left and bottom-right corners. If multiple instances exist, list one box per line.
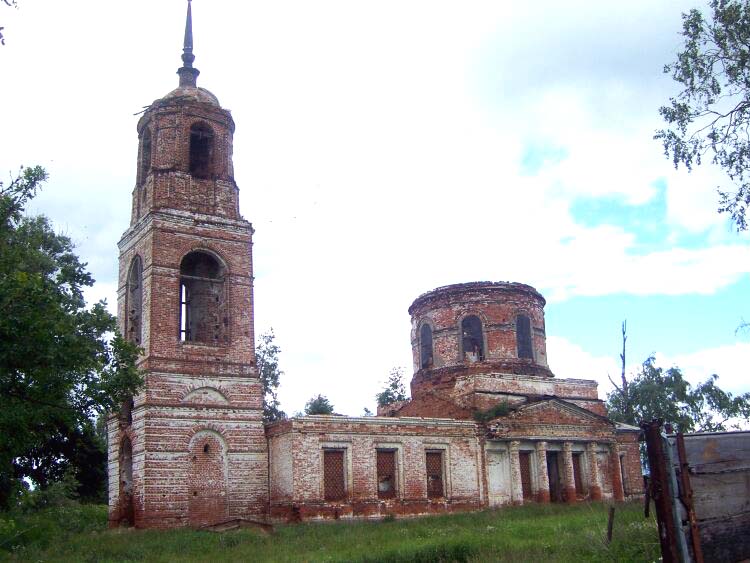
left=0, top=166, right=142, bottom=507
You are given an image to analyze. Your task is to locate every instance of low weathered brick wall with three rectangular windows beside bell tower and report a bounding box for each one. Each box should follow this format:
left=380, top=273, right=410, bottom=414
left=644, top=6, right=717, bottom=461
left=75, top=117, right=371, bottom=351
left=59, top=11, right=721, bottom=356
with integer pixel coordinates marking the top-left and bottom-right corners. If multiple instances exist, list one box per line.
left=268, top=416, right=483, bottom=519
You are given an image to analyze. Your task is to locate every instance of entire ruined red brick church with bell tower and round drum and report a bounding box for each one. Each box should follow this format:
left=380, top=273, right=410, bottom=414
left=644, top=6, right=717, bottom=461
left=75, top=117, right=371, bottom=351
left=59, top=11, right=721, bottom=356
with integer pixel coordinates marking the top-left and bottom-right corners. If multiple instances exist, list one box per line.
left=108, top=3, right=642, bottom=527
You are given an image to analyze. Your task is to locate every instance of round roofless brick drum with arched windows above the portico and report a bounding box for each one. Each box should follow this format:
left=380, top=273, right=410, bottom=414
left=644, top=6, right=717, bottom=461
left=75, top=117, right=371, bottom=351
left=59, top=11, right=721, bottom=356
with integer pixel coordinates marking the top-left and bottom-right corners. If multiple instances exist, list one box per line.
left=394, top=282, right=576, bottom=418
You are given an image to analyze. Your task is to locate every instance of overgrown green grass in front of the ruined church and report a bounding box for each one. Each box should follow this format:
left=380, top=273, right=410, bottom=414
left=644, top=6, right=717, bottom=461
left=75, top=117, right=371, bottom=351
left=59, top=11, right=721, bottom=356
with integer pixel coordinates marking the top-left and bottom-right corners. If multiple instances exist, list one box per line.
left=0, top=503, right=659, bottom=563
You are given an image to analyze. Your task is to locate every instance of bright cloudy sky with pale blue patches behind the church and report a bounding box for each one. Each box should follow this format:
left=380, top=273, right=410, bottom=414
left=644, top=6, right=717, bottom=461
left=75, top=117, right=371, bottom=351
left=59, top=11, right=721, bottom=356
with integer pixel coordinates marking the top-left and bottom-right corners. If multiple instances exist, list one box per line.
left=0, top=0, right=750, bottom=414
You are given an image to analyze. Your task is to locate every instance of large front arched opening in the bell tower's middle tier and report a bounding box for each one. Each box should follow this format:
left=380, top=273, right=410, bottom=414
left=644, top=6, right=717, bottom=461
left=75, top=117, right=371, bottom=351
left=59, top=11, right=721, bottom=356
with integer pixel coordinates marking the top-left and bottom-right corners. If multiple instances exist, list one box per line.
left=180, top=251, right=229, bottom=344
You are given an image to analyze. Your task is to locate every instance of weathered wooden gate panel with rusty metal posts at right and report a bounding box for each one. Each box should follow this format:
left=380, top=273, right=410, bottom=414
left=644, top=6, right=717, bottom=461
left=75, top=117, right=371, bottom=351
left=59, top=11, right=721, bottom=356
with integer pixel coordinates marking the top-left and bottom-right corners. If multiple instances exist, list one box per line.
left=641, top=420, right=750, bottom=563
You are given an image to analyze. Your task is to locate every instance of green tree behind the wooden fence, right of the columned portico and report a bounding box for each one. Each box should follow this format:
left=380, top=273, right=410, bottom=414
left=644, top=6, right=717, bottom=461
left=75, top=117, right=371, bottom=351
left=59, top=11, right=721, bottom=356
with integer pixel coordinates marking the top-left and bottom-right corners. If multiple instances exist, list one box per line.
left=607, top=357, right=750, bottom=432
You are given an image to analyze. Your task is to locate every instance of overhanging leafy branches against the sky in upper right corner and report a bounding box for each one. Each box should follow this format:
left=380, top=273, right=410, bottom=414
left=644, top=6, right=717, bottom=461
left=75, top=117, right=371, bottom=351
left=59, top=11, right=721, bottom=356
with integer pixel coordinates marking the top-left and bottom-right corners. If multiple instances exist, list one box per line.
left=655, top=0, right=750, bottom=230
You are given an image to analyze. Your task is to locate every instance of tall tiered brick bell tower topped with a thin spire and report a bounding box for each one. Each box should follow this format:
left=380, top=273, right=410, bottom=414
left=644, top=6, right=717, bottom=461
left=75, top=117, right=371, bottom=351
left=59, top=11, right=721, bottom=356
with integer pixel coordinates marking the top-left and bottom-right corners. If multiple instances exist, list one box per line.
left=108, top=0, right=268, bottom=527
